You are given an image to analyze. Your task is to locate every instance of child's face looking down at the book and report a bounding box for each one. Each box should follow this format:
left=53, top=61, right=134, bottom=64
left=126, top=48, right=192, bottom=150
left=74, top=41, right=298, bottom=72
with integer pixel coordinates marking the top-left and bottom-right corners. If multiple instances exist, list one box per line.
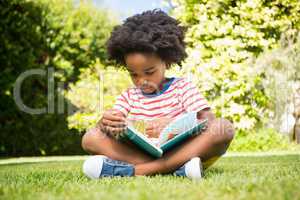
left=125, top=53, right=166, bottom=94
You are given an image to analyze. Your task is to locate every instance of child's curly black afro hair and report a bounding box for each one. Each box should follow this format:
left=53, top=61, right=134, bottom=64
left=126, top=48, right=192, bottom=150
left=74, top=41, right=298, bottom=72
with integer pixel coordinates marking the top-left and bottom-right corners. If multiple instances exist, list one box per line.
left=107, top=9, right=187, bottom=68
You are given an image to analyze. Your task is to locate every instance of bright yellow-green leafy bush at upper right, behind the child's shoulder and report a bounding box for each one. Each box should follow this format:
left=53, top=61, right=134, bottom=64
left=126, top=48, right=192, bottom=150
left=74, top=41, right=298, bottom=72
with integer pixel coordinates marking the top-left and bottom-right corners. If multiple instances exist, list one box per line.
left=172, top=0, right=300, bottom=131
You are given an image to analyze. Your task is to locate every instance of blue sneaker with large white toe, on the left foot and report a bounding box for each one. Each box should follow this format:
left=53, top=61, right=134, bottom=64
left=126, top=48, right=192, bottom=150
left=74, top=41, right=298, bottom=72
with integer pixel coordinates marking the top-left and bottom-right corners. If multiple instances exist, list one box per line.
left=82, top=155, right=134, bottom=179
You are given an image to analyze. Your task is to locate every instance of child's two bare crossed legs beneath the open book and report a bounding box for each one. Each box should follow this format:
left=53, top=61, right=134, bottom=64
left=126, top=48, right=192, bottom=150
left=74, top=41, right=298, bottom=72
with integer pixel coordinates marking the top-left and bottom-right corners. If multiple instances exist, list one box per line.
left=82, top=119, right=234, bottom=175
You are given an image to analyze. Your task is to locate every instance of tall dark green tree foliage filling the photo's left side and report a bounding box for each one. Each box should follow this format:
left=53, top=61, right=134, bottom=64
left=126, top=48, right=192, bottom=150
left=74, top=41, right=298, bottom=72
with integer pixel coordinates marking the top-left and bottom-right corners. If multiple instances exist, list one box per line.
left=0, top=0, right=115, bottom=156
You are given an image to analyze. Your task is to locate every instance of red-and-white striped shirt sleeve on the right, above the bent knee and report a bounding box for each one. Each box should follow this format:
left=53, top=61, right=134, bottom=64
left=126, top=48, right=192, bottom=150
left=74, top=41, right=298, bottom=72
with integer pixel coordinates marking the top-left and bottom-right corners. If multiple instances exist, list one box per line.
left=182, top=80, right=210, bottom=112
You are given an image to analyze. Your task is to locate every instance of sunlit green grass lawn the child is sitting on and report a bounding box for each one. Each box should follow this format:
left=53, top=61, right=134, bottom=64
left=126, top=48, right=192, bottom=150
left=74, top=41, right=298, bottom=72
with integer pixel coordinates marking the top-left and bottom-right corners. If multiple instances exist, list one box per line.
left=0, top=153, right=300, bottom=200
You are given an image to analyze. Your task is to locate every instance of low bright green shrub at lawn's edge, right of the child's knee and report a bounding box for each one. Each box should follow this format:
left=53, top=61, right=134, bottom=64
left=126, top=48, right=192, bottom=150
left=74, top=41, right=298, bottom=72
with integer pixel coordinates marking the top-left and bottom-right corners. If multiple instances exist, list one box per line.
left=229, top=129, right=300, bottom=152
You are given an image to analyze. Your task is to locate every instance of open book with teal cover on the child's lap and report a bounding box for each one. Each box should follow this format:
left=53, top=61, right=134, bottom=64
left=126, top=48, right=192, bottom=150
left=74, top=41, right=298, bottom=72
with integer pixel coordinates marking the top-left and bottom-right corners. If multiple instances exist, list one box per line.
left=121, top=112, right=207, bottom=158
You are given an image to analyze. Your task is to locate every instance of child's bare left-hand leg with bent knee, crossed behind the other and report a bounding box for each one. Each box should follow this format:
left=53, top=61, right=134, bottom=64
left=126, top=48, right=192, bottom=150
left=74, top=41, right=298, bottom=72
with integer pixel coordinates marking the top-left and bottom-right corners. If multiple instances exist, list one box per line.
left=82, top=128, right=153, bottom=165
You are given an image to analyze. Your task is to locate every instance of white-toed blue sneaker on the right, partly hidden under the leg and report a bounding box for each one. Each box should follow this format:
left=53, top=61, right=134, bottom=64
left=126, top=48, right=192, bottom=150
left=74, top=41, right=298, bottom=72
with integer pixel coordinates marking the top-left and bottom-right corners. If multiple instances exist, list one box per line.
left=174, top=157, right=203, bottom=180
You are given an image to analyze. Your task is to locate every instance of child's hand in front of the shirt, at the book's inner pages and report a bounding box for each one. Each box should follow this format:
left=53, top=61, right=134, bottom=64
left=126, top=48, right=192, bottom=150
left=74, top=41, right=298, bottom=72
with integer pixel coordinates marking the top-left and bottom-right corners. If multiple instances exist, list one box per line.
left=146, top=118, right=173, bottom=138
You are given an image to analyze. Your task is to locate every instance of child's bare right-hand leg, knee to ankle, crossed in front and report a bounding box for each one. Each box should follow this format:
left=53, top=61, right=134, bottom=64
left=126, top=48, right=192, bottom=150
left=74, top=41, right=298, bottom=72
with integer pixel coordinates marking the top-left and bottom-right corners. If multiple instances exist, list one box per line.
left=135, top=119, right=234, bottom=175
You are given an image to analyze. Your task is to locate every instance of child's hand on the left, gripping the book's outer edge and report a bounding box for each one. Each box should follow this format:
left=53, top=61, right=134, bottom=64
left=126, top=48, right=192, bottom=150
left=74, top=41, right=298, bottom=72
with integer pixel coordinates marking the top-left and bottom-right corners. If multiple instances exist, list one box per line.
left=97, top=109, right=126, bottom=136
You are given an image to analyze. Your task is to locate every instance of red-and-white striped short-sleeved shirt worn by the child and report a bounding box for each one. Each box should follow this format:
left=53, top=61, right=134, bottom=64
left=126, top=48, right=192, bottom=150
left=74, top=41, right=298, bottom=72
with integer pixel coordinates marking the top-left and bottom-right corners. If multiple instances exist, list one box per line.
left=113, top=78, right=209, bottom=120
